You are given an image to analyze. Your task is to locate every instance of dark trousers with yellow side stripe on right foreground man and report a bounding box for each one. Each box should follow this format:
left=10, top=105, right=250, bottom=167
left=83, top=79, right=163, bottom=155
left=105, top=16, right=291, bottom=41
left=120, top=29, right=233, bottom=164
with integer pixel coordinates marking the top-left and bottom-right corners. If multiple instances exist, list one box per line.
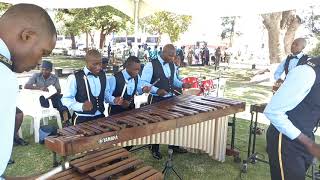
left=267, top=125, right=314, bottom=180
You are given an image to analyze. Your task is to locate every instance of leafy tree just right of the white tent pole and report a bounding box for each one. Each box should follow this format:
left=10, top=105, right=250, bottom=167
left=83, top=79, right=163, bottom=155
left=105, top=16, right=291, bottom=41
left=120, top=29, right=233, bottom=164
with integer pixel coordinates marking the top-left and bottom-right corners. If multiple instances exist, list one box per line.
left=141, top=11, right=192, bottom=43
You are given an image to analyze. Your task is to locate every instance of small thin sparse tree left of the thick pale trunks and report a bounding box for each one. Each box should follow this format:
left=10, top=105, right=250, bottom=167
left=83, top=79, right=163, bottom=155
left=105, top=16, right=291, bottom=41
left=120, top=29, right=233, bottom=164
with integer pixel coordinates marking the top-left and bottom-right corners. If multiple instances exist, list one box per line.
left=220, top=16, right=241, bottom=47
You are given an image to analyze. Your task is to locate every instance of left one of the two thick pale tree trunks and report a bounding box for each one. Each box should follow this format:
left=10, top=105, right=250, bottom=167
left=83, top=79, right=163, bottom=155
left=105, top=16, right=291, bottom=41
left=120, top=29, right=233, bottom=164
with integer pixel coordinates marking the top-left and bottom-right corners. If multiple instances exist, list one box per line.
left=262, top=12, right=282, bottom=64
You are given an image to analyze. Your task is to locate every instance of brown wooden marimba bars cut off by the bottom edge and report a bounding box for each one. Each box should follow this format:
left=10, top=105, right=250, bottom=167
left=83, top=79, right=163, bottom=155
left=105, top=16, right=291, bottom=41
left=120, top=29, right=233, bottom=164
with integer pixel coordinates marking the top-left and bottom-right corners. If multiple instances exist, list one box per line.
left=39, top=147, right=163, bottom=180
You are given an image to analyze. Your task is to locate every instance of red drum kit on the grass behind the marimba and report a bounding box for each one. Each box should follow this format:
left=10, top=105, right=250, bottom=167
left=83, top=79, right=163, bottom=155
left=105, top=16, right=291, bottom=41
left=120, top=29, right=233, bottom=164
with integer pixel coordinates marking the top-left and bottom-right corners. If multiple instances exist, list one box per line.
left=182, top=77, right=220, bottom=96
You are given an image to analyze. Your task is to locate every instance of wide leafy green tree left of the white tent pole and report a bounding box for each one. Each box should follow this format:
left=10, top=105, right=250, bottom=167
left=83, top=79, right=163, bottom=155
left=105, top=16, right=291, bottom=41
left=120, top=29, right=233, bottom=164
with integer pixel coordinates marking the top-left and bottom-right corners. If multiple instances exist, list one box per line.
left=57, top=6, right=130, bottom=49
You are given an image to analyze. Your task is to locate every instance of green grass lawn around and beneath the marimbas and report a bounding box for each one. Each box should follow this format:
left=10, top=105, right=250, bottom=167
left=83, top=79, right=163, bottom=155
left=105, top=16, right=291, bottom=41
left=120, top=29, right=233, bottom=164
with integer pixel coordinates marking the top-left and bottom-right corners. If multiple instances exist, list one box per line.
left=6, top=57, right=271, bottom=180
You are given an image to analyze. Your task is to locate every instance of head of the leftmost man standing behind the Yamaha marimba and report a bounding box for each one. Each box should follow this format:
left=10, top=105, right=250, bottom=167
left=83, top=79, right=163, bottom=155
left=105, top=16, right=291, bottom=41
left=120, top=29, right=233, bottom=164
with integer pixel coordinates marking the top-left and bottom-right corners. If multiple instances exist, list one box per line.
left=85, top=49, right=102, bottom=75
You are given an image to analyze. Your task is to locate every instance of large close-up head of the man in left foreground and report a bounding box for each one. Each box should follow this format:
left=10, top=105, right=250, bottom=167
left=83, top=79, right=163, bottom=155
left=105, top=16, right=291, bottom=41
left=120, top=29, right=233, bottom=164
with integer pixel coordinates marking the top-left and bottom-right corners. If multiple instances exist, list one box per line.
left=0, top=4, right=57, bottom=73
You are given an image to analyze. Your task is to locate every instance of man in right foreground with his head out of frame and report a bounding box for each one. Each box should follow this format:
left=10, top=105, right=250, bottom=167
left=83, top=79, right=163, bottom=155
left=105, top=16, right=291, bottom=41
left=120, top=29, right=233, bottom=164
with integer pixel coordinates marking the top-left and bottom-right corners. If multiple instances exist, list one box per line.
left=264, top=57, right=320, bottom=180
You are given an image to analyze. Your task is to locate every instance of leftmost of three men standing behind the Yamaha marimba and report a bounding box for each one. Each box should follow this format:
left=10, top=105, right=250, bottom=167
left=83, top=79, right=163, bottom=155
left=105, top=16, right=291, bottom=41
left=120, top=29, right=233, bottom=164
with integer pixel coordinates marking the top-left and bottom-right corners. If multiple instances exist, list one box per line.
left=61, top=49, right=107, bottom=124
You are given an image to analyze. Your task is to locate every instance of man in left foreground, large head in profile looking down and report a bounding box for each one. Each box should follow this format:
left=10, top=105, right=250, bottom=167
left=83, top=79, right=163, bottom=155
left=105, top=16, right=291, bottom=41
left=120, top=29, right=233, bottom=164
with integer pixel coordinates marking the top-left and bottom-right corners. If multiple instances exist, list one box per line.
left=0, top=4, right=57, bottom=176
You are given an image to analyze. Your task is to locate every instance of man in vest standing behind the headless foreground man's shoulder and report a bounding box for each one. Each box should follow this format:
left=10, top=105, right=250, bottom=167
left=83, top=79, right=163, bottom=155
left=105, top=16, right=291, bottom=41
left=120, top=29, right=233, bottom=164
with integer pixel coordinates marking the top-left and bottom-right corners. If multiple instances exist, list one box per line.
left=274, top=38, right=309, bottom=84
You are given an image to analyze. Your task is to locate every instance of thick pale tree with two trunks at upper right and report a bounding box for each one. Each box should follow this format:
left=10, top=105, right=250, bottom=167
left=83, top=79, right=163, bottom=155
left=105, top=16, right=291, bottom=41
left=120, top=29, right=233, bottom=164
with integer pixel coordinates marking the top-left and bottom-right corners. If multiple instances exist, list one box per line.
left=261, top=10, right=302, bottom=64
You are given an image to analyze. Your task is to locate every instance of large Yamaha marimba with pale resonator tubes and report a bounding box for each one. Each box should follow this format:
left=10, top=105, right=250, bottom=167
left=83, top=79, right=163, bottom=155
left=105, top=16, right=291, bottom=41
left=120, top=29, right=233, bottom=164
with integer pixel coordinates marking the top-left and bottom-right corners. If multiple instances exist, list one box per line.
left=45, top=95, right=245, bottom=161
